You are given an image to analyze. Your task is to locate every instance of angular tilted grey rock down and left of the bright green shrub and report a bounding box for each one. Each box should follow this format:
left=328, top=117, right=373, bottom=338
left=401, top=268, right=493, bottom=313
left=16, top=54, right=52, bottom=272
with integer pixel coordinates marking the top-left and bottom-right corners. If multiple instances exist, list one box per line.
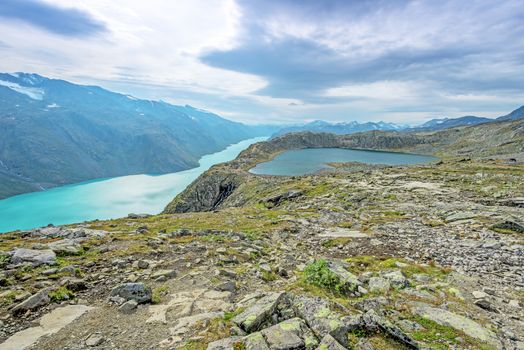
left=232, top=292, right=284, bottom=333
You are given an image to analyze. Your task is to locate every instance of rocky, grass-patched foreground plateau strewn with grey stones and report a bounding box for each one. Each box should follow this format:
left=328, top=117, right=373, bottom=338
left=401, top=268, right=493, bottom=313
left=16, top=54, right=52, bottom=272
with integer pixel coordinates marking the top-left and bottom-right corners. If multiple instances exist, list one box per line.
left=0, top=123, right=524, bottom=350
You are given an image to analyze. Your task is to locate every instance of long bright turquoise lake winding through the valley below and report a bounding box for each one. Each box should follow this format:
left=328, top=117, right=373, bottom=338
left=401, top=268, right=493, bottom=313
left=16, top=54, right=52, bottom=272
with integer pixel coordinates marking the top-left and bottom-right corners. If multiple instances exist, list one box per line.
left=0, top=137, right=267, bottom=232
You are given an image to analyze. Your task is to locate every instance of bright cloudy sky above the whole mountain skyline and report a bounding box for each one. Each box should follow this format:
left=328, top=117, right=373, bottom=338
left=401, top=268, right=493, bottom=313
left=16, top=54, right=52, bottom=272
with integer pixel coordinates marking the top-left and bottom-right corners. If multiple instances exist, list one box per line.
left=0, top=0, right=524, bottom=124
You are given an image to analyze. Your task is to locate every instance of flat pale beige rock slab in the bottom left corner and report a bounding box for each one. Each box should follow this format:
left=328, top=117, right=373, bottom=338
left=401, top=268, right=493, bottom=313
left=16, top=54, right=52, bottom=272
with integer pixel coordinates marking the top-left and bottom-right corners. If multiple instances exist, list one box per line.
left=0, top=305, right=92, bottom=350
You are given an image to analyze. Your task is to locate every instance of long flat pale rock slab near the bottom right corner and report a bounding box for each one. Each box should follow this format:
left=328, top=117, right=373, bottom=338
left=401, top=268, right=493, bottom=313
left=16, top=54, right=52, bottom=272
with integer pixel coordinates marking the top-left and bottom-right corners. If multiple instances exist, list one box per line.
left=413, top=306, right=500, bottom=347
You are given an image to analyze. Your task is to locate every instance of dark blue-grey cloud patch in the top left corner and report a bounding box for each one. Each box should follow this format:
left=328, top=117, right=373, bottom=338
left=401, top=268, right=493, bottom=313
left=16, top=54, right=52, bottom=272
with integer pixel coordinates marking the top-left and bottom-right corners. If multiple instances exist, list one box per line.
left=0, top=0, right=106, bottom=37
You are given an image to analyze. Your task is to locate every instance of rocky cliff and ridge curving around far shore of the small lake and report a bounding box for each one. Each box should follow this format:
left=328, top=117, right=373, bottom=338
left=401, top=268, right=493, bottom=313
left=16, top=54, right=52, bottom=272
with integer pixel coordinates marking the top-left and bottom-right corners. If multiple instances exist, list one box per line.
left=164, top=120, right=524, bottom=213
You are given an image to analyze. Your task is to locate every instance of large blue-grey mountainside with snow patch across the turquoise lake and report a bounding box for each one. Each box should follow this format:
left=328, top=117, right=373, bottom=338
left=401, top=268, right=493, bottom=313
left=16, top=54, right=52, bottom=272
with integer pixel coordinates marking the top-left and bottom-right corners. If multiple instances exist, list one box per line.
left=0, top=73, right=276, bottom=198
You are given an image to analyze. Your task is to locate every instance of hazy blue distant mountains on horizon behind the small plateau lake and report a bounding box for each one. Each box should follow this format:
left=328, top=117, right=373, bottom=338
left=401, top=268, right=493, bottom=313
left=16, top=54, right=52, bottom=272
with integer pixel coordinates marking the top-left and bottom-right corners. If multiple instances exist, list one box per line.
left=273, top=120, right=403, bottom=136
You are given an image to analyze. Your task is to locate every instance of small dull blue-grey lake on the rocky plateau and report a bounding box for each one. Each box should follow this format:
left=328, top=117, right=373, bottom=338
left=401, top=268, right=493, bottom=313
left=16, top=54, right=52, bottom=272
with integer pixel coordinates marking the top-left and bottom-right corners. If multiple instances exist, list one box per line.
left=250, top=148, right=438, bottom=176
